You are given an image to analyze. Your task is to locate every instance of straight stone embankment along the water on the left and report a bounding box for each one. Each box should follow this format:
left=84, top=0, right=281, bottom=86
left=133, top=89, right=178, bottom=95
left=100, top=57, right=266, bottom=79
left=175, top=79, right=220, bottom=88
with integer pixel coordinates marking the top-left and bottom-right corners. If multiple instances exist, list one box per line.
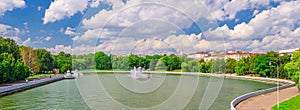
left=0, top=75, right=64, bottom=97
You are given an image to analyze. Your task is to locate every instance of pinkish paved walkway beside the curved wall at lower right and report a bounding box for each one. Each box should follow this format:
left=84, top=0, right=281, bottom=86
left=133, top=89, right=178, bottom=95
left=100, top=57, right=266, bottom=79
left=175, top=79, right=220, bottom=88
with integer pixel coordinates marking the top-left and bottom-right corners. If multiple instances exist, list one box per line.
left=236, top=86, right=298, bottom=110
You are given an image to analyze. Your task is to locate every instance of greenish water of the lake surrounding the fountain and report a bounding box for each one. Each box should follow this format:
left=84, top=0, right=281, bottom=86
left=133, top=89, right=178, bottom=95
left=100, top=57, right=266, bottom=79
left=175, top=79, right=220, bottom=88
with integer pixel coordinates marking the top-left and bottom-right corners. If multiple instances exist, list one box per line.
left=0, top=73, right=275, bottom=110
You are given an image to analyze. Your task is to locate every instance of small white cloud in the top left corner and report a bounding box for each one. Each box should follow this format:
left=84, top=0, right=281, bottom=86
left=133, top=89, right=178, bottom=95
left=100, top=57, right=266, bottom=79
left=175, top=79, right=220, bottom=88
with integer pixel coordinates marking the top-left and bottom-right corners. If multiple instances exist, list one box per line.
left=0, top=0, right=25, bottom=16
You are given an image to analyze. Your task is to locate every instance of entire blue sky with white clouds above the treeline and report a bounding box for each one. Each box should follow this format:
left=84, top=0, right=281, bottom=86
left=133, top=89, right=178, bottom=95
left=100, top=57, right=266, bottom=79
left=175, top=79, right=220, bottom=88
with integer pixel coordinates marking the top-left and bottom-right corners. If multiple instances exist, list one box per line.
left=0, top=0, right=300, bottom=54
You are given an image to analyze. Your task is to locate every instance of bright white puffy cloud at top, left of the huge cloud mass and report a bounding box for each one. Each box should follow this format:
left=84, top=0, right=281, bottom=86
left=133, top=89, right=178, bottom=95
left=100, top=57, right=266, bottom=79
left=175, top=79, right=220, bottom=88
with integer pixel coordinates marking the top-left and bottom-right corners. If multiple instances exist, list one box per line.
left=43, top=0, right=88, bottom=24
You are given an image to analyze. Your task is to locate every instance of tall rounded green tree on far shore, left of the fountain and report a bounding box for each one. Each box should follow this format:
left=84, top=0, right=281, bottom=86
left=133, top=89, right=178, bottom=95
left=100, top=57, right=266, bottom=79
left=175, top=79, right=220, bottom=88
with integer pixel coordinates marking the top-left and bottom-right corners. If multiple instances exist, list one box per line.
left=95, top=52, right=111, bottom=70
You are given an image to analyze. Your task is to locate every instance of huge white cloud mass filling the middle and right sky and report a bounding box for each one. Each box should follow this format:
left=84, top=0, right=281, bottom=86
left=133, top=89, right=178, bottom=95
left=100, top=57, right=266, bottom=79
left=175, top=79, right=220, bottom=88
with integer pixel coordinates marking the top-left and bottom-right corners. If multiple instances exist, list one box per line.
left=63, top=0, right=300, bottom=55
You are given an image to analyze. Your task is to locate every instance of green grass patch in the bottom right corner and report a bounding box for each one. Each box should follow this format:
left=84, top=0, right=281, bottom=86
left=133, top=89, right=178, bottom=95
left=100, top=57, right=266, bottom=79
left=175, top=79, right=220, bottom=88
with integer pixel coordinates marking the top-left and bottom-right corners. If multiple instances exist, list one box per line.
left=272, top=95, right=300, bottom=110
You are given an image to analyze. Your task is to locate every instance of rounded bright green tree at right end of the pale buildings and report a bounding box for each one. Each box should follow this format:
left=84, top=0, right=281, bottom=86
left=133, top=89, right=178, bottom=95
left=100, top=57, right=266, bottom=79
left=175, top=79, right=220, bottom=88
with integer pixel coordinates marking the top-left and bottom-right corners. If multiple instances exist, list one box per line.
left=234, top=58, right=249, bottom=75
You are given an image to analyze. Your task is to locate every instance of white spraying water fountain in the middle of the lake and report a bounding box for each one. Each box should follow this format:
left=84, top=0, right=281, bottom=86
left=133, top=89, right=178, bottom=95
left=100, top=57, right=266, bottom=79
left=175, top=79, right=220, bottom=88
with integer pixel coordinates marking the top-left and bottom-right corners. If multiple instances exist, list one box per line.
left=129, top=67, right=151, bottom=79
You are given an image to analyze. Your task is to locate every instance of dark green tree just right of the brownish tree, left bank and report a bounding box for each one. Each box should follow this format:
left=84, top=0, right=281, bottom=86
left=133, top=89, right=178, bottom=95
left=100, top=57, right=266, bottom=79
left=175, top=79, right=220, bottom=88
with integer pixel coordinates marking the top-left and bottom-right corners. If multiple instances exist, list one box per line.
left=36, top=49, right=53, bottom=72
